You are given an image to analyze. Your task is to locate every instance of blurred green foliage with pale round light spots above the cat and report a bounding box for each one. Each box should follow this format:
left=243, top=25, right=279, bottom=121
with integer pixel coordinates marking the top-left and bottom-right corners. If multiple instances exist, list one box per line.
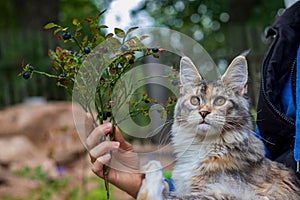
left=133, top=0, right=284, bottom=52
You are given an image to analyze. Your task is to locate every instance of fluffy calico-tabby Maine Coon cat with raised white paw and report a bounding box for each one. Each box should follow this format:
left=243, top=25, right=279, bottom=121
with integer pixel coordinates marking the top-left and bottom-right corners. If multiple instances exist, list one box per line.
left=138, top=56, right=300, bottom=200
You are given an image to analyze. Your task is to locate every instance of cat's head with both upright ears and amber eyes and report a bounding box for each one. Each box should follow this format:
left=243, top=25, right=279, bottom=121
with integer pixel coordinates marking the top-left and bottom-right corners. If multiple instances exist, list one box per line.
left=175, top=56, right=249, bottom=141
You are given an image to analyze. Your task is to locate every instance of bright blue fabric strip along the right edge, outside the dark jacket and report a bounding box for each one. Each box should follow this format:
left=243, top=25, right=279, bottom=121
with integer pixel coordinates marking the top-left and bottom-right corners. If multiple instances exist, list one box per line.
left=294, top=48, right=300, bottom=162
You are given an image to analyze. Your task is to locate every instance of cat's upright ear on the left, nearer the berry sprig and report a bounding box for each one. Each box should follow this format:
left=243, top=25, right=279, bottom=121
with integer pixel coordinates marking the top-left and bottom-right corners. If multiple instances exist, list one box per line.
left=180, top=57, right=202, bottom=86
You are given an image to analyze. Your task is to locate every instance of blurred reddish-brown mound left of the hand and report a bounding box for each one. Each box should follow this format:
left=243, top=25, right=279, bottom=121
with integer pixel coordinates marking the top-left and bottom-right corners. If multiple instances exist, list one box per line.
left=0, top=101, right=85, bottom=165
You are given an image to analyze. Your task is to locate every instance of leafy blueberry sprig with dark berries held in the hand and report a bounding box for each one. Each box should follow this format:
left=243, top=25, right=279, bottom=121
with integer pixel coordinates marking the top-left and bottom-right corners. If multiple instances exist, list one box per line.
left=19, top=11, right=174, bottom=199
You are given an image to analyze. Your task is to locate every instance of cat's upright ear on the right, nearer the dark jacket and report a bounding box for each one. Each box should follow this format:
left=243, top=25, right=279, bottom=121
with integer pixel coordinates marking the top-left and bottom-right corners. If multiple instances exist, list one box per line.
left=221, top=56, right=248, bottom=95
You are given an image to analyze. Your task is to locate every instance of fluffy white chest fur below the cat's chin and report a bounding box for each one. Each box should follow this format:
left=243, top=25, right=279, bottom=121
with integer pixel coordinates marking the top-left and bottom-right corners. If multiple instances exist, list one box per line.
left=172, top=125, right=227, bottom=196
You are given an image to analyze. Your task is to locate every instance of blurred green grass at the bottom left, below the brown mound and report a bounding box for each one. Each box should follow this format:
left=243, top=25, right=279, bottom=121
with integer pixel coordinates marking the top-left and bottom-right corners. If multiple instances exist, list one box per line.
left=1, top=166, right=116, bottom=200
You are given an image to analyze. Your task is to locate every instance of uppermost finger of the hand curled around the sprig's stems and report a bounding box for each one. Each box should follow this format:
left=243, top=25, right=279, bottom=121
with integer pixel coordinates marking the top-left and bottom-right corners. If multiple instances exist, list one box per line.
left=86, top=123, right=111, bottom=149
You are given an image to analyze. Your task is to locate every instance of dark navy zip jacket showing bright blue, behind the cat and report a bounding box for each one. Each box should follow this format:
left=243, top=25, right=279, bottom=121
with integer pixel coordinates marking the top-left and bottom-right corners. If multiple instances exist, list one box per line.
left=257, top=1, right=300, bottom=173
